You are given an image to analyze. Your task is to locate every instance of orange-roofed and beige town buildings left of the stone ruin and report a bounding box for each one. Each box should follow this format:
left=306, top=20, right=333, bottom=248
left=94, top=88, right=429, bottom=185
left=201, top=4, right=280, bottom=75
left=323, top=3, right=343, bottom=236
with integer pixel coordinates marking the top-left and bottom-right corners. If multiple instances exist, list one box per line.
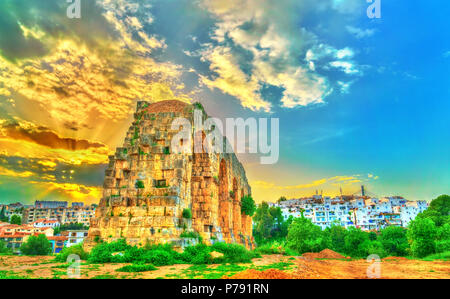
left=0, top=201, right=96, bottom=253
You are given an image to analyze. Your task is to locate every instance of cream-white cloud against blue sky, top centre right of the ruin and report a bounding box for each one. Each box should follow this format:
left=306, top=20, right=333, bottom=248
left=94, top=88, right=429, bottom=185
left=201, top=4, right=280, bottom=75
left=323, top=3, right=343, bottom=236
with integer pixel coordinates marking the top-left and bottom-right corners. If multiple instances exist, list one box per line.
left=197, top=0, right=358, bottom=111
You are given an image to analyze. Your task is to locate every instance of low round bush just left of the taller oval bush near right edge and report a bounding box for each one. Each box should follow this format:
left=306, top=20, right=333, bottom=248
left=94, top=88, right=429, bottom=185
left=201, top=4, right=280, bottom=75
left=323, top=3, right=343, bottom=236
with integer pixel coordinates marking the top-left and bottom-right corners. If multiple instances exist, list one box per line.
left=379, top=226, right=409, bottom=256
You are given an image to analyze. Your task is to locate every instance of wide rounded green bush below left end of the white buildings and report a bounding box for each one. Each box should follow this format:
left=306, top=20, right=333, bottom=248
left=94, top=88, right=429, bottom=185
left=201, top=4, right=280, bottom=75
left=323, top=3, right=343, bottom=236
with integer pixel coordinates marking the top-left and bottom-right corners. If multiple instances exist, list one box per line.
left=287, top=218, right=330, bottom=254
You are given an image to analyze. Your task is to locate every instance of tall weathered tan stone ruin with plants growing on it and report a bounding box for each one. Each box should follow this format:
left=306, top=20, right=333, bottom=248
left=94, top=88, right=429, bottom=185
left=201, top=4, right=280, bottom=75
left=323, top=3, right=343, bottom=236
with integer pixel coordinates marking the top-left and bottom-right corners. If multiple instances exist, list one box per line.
left=85, top=100, right=253, bottom=250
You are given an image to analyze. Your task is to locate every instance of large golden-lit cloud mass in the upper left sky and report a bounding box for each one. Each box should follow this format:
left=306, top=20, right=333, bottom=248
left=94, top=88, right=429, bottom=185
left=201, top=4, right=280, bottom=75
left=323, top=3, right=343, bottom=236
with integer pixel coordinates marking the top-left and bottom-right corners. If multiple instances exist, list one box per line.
left=0, top=0, right=190, bottom=130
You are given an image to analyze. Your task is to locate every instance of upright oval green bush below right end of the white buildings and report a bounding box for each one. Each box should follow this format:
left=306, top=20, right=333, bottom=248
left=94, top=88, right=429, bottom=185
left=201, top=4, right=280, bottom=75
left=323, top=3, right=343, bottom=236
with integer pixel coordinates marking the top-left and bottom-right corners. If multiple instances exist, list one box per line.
left=407, top=218, right=438, bottom=257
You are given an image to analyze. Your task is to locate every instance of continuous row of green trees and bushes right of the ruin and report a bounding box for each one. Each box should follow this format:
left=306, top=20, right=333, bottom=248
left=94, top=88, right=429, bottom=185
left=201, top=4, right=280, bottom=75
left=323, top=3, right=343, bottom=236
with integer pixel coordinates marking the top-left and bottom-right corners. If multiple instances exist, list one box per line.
left=253, top=195, right=450, bottom=259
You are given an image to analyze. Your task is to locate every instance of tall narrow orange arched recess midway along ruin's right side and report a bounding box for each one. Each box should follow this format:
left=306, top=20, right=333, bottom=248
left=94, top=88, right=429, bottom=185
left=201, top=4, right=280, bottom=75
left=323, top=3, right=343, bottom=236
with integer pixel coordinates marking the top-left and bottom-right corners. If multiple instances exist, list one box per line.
left=218, top=159, right=230, bottom=241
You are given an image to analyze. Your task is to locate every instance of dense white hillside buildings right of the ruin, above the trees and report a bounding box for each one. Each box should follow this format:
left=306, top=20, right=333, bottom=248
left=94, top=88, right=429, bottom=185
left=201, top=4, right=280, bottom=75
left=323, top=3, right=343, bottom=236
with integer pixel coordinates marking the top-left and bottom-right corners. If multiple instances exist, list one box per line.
left=270, top=191, right=428, bottom=231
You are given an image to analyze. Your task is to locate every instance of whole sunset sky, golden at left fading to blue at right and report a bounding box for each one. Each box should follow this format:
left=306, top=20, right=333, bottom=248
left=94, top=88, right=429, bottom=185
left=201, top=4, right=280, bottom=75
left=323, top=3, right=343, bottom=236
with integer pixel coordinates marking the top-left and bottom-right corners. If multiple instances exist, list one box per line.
left=0, top=0, right=450, bottom=203
